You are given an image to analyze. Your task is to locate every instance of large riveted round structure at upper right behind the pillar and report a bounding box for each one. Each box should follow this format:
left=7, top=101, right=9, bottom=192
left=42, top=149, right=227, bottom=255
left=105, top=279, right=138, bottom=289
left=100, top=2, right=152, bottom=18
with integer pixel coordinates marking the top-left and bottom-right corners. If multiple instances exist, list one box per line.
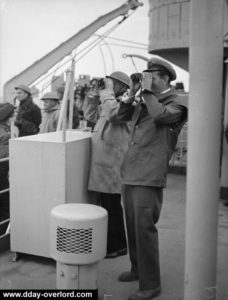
left=148, top=0, right=228, bottom=70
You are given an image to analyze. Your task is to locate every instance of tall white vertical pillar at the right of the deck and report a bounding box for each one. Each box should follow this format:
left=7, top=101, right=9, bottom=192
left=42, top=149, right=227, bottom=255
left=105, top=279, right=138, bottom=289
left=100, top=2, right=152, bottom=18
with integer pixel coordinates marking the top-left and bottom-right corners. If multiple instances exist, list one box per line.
left=184, top=0, right=224, bottom=300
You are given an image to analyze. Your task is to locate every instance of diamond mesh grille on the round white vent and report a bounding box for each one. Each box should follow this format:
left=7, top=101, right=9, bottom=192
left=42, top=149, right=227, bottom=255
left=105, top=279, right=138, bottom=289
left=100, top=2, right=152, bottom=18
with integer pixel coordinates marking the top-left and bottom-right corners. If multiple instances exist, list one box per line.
left=56, top=226, right=93, bottom=254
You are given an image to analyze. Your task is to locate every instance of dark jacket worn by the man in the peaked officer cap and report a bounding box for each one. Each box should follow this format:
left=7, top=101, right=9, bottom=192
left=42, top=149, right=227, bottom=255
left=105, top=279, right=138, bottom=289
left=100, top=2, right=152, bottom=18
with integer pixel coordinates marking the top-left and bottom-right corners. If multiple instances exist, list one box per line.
left=115, top=91, right=187, bottom=187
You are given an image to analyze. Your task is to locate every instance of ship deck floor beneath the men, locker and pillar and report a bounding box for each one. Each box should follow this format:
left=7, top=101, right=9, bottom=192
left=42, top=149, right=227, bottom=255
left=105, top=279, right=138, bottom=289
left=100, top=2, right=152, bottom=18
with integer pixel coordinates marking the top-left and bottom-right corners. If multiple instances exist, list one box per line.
left=0, top=174, right=228, bottom=300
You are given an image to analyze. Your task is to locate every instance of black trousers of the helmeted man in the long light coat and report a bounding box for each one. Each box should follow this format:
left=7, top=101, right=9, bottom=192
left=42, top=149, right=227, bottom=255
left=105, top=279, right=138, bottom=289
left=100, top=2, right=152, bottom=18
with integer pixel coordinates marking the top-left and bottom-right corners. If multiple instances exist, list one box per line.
left=100, top=193, right=127, bottom=253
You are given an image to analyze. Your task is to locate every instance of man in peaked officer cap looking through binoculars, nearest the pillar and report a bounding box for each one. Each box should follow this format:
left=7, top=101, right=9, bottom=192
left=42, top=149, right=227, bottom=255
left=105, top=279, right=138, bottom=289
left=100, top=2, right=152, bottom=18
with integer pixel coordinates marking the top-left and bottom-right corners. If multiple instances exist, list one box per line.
left=115, top=58, right=187, bottom=300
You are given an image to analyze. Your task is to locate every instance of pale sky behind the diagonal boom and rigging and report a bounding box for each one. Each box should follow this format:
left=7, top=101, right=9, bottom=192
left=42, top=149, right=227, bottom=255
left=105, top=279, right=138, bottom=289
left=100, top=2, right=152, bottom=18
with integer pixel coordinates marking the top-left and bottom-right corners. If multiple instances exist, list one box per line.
left=0, top=0, right=188, bottom=95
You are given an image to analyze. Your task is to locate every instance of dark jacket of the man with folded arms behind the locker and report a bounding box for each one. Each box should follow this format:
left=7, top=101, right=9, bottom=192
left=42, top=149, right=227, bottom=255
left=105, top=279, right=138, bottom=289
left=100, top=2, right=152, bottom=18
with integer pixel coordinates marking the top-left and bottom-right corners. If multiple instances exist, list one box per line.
left=15, top=97, right=41, bottom=137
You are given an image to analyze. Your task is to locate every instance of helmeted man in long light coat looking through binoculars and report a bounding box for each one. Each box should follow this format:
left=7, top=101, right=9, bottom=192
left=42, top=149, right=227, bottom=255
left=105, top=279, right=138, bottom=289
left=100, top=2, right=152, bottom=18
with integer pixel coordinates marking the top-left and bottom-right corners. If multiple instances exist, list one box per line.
left=84, top=71, right=130, bottom=258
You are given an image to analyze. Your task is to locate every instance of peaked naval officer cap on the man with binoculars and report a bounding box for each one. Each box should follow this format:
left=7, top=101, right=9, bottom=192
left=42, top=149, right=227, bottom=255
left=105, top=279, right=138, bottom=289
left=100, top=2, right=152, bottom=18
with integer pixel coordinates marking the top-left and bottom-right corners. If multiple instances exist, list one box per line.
left=143, top=57, right=177, bottom=81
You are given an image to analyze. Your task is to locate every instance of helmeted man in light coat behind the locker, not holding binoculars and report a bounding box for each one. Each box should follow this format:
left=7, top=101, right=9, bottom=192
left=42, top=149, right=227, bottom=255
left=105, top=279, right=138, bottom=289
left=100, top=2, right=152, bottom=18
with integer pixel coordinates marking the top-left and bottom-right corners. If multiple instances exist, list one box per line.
left=40, top=92, right=60, bottom=133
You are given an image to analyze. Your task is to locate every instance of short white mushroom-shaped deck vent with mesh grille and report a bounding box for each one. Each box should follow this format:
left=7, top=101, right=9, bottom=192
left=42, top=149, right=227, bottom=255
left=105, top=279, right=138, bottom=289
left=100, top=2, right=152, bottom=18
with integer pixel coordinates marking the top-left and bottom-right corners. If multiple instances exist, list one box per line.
left=50, top=203, right=108, bottom=290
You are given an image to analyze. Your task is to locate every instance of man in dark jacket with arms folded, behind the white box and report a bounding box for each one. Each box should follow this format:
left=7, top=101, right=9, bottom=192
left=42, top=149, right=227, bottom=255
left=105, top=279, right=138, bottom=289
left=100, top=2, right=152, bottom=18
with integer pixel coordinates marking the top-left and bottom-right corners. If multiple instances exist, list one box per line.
left=14, top=85, right=41, bottom=137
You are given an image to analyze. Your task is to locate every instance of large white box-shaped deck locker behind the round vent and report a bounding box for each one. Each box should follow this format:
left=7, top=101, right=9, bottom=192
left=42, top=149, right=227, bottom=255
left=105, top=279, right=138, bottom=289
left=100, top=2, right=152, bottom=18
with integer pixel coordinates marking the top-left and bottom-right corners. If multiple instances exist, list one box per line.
left=10, top=130, right=91, bottom=257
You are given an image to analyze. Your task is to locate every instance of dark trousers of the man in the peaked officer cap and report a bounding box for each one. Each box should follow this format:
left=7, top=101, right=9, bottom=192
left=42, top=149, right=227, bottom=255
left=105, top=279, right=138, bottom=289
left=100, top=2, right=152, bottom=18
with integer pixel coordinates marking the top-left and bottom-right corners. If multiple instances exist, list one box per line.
left=123, top=185, right=163, bottom=290
